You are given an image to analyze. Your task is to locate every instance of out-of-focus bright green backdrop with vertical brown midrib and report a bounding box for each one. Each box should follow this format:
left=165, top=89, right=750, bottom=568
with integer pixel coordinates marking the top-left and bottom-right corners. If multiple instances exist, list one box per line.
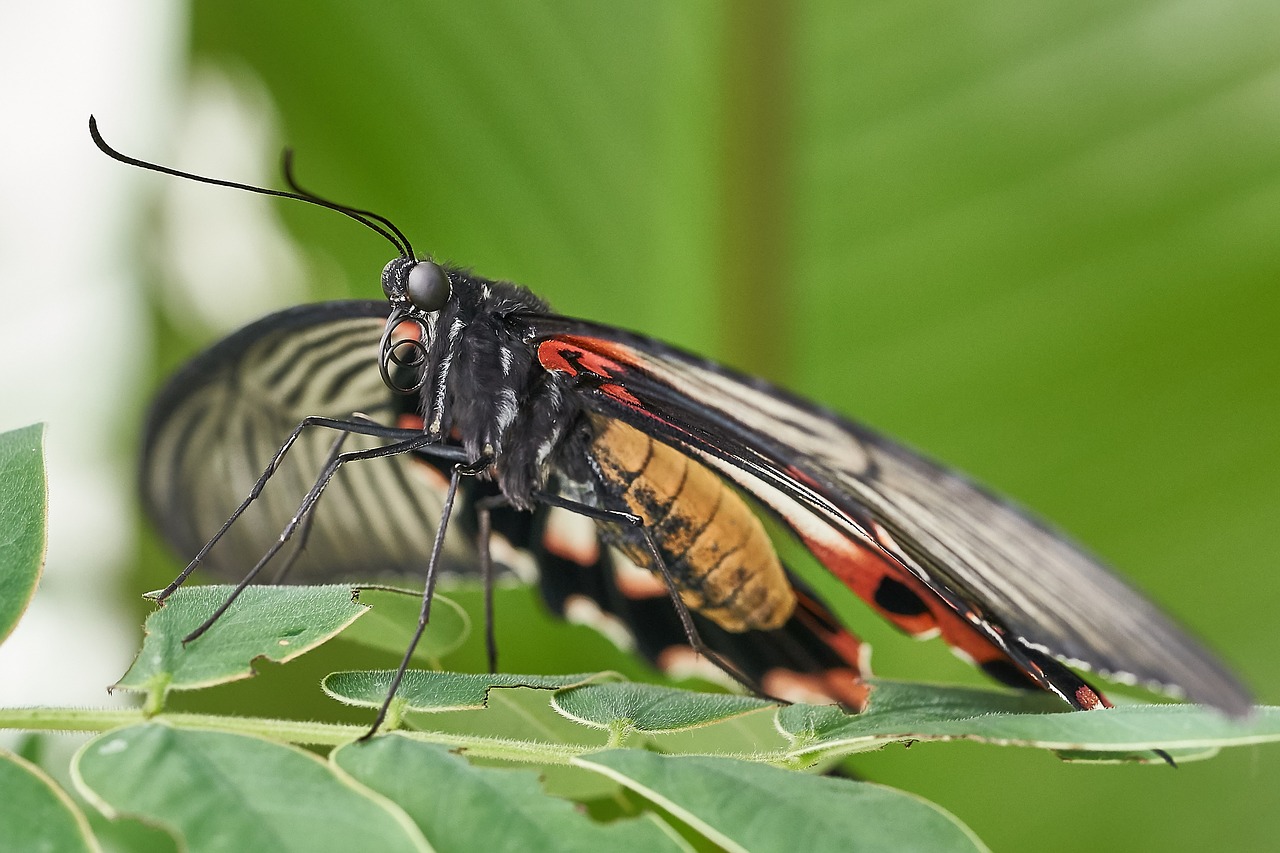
left=109, top=0, right=1280, bottom=850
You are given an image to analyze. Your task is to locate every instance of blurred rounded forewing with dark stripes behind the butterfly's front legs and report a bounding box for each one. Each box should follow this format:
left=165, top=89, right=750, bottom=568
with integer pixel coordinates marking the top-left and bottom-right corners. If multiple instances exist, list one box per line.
left=141, top=301, right=463, bottom=583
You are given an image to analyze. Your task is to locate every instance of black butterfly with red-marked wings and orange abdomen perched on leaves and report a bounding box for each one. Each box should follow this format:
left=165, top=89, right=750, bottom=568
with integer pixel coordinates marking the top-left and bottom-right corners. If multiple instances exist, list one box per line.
left=91, top=112, right=1251, bottom=727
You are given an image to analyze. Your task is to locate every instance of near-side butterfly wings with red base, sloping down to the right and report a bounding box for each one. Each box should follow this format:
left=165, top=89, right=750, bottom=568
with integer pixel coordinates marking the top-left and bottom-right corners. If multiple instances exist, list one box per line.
left=521, top=315, right=1251, bottom=715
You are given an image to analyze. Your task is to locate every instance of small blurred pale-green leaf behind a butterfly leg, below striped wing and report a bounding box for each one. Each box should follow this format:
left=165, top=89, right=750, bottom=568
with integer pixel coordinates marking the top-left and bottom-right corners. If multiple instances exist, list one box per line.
left=342, top=587, right=471, bottom=663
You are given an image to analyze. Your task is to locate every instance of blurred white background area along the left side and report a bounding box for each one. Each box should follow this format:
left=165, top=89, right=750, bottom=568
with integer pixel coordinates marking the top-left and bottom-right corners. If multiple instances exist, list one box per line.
left=0, top=0, right=301, bottom=706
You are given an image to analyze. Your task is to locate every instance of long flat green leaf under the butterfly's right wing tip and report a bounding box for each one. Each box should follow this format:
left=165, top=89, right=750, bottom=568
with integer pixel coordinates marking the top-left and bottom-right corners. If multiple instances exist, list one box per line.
left=778, top=681, right=1280, bottom=761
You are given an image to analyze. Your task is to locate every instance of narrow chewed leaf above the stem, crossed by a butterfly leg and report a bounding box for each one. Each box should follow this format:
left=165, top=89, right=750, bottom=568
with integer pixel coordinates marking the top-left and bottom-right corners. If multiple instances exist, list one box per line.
left=320, top=670, right=612, bottom=711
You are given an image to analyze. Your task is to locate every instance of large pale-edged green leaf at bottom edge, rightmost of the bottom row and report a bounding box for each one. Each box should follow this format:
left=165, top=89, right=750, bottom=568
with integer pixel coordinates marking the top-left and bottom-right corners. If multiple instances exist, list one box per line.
left=575, top=749, right=986, bottom=853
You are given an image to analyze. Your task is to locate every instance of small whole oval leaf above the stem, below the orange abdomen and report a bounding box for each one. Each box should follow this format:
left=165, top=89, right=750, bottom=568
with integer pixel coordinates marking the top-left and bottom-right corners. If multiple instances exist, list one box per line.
left=552, top=683, right=773, bottom=731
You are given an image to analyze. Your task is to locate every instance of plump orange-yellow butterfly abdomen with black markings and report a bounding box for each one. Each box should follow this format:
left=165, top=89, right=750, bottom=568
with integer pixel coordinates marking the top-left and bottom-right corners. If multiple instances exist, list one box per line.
left=591, top=418, right=796, bottom=631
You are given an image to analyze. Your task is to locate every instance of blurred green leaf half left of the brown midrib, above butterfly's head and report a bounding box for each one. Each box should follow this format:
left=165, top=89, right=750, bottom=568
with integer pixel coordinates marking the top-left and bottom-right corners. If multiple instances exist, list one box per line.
left=186, top=0, right=718, bottom=342
